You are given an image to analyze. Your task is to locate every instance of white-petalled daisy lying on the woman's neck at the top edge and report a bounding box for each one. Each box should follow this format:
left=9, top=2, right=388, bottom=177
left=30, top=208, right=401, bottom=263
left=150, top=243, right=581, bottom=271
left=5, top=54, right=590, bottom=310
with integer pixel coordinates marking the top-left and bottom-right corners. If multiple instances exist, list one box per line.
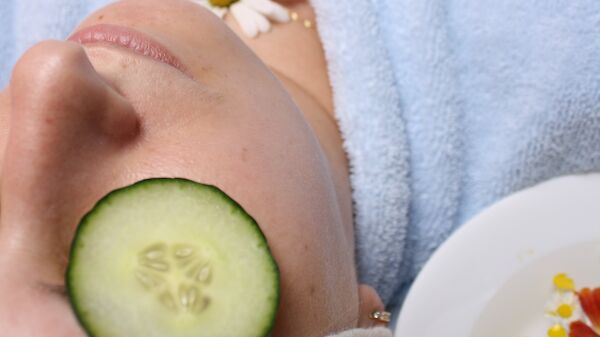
left=193, top=0, right=290, bottom=38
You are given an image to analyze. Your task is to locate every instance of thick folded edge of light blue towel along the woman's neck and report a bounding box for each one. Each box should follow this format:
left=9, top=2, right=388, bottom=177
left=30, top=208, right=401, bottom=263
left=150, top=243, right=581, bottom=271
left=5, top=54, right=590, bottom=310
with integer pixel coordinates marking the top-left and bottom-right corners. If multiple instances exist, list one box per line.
left=312, top=0, right=411, bottom=316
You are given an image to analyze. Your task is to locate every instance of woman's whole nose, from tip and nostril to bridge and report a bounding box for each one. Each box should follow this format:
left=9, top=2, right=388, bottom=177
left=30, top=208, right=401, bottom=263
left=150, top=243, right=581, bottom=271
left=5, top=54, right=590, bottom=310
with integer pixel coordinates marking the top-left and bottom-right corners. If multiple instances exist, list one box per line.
left=0, top=41, right=139, bottom=247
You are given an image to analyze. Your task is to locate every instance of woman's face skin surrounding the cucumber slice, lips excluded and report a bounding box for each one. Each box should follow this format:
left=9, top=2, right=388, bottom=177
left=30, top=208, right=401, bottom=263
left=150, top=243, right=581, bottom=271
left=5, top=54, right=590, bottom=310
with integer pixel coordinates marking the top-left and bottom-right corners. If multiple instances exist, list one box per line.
left=0, top=0, right=366, bottom=337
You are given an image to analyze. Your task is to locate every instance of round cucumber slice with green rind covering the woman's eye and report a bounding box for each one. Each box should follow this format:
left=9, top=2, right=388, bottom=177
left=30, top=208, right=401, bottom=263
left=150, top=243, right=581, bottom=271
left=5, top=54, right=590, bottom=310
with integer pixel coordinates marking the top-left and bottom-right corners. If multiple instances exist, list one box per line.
left=66, top=178, right=279, bottom=337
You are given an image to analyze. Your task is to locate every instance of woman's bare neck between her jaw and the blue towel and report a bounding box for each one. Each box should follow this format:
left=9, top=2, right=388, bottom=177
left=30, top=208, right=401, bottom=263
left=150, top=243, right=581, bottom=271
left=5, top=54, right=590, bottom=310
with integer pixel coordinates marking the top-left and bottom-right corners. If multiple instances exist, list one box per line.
left=225, top=0, right=354, bottom=241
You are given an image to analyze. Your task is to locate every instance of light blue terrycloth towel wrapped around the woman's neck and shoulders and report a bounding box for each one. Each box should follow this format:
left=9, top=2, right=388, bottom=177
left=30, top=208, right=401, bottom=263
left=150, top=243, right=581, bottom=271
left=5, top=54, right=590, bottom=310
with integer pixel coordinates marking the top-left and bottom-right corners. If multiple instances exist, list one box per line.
left=0, top=0, right=600, bottom=316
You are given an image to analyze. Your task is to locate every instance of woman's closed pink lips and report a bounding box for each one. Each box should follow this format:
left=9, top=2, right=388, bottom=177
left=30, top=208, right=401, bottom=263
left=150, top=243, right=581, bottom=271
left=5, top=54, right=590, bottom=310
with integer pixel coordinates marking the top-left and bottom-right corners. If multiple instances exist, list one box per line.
left=68, top=24, right=189, bottom=76
